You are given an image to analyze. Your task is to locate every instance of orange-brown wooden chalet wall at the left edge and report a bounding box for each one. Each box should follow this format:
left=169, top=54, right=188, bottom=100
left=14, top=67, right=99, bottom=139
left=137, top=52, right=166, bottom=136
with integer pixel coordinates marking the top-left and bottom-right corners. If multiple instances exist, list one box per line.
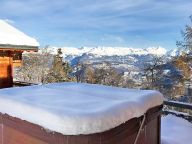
left=0, top=50, right=13, bottom=88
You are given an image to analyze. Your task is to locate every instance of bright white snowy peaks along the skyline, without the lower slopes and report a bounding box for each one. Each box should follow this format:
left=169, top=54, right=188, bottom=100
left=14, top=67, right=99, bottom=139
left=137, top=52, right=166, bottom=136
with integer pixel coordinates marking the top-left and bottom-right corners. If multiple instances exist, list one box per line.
left=50, top=47, right=167, bottom=56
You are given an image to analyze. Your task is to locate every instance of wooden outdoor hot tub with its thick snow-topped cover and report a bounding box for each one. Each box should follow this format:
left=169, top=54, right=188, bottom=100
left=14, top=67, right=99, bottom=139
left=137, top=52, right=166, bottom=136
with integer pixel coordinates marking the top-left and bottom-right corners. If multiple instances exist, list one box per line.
left=0, top=83, right=163, bottom=144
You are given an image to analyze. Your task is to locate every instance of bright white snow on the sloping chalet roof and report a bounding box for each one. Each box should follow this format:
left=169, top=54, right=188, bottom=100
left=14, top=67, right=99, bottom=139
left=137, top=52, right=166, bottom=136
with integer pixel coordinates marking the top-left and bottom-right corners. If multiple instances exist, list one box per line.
left=0, top=19, right=39, bottom=46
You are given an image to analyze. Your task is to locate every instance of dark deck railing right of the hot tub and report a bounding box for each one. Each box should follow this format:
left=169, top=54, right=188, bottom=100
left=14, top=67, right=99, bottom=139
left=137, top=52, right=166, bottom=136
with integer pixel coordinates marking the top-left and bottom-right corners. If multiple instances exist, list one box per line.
left=163, top=100, right=192, bottom=122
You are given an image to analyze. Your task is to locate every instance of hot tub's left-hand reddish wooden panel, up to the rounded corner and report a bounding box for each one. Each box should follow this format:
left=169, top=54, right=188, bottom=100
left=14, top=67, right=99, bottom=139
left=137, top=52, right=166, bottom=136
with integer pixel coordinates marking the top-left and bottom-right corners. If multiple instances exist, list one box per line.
left=0, top=114, right=67, bottom=144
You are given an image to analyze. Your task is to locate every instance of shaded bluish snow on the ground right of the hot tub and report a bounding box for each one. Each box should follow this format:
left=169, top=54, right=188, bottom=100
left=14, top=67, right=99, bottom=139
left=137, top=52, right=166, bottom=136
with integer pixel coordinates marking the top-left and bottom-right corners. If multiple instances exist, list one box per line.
left=161, top=115, right=192, bottom=144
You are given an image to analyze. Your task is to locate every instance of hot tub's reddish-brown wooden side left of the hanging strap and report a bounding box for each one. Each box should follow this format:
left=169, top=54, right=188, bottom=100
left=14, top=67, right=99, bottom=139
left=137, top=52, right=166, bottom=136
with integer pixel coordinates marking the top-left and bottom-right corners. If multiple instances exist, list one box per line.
left=0, top=115, right=141, bottom=144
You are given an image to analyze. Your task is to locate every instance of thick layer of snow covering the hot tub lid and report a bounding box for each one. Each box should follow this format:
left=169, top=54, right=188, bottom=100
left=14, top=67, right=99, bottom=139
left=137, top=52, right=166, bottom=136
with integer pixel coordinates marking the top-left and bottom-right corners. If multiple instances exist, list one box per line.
left=0, top=83, right=163, bottom=135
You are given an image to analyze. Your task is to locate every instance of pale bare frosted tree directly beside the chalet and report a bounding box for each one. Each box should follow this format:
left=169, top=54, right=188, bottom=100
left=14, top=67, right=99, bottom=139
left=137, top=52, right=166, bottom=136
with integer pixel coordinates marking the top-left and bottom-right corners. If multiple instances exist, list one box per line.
left=15, top=47, right=53, bottom=83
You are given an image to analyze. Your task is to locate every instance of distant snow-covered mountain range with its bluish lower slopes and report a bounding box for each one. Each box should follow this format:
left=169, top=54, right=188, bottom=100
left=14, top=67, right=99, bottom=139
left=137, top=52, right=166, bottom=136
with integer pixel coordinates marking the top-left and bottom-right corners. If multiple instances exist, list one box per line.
left=24, top=47, right=177, bottom=82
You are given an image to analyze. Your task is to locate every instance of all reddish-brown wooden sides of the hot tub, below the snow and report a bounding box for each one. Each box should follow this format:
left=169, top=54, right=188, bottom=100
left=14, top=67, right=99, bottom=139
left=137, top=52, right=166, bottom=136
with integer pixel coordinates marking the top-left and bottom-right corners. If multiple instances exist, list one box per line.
left=0, top=107, right=161, bottom=144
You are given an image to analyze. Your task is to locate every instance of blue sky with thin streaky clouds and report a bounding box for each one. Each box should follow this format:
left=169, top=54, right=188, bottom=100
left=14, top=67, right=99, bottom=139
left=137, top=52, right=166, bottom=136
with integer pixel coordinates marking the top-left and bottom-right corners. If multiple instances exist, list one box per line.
left=0, top=0, right=192, bottom=49
